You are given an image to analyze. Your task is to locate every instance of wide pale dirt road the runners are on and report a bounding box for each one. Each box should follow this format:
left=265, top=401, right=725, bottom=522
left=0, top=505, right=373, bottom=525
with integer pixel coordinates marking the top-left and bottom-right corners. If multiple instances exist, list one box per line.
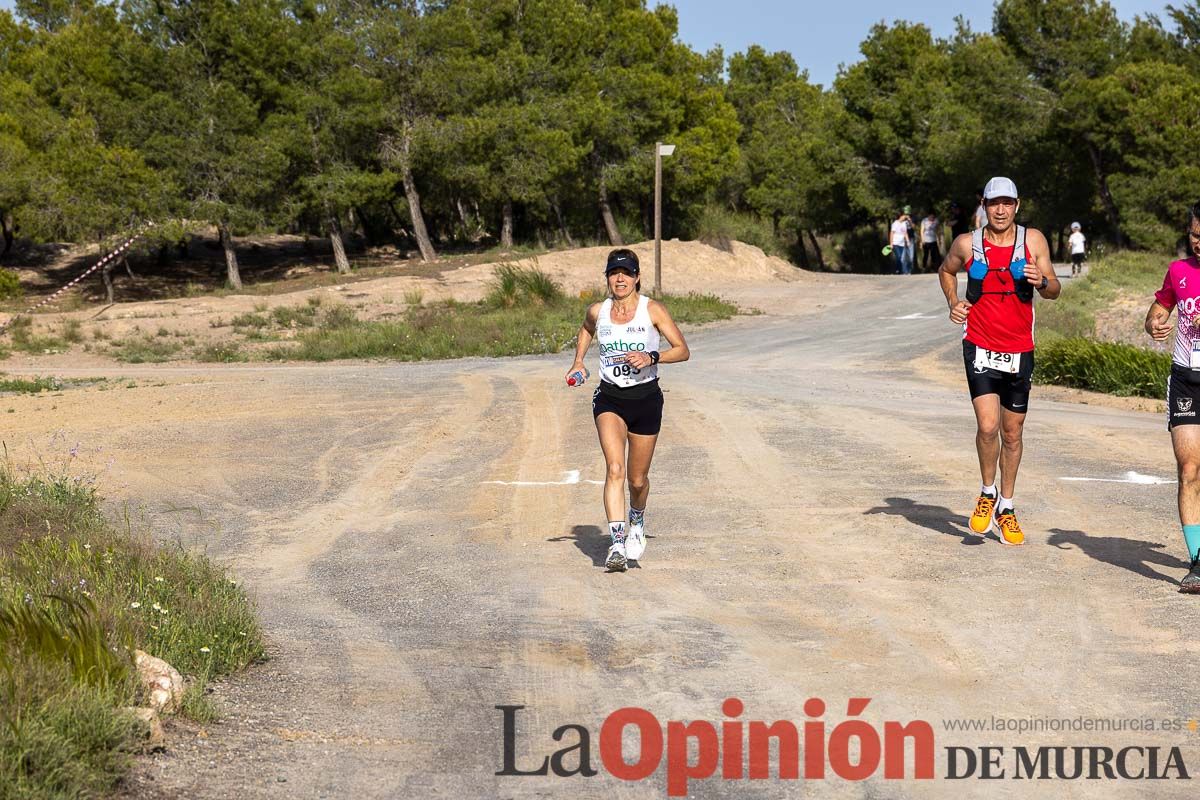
left=6, top=276, right=1200, bottom=798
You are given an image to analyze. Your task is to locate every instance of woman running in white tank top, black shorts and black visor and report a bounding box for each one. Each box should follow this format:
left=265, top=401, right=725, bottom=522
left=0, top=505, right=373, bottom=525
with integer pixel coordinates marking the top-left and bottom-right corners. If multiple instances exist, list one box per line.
left=566, top=249, right=691, bottom=572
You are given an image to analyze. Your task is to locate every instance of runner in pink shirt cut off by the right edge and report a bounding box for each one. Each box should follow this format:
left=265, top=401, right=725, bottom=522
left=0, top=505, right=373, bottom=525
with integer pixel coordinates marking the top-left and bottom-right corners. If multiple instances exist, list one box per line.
left=1146, top=203, right=1200, bottom=595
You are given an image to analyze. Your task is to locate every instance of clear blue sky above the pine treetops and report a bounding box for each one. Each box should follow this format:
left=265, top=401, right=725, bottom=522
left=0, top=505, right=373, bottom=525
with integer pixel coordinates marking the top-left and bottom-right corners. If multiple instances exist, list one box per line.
left=0, top=0, right=1183, bottom=86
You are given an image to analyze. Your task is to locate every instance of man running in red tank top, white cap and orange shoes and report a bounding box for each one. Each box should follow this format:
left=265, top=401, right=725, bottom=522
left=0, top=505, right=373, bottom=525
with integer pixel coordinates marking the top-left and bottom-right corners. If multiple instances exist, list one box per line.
left=938, top=178, right=1062, bottom=545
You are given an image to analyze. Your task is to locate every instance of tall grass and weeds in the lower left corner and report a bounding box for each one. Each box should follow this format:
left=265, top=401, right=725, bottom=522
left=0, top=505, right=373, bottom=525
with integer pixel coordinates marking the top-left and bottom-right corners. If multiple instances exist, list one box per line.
left=0, top=470, right=263, bottom=800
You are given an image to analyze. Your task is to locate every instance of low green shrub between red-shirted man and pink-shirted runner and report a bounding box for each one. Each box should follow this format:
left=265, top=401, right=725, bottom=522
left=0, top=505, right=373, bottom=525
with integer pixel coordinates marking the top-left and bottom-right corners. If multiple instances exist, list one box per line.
left=1034, top=338, right=1171, bottom=397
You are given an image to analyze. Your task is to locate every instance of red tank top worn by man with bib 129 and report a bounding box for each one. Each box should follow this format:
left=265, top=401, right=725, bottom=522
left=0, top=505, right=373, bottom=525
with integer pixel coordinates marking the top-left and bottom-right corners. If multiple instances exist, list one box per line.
left=962, top=236, right=1033, bottom=353
